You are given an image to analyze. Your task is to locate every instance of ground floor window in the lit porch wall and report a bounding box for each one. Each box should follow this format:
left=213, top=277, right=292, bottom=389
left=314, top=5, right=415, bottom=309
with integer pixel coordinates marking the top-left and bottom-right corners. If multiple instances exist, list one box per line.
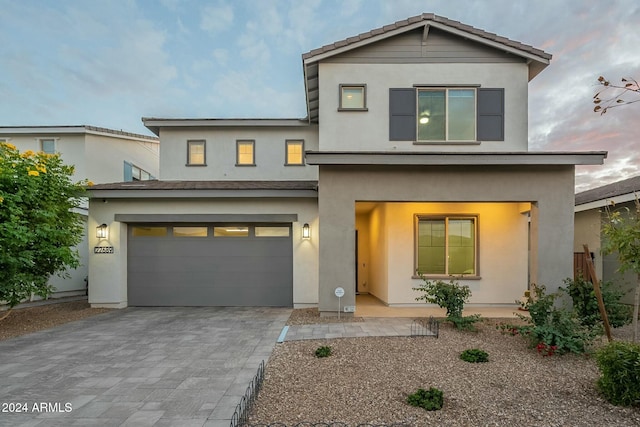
left=416, top=215, right=478, bottom=275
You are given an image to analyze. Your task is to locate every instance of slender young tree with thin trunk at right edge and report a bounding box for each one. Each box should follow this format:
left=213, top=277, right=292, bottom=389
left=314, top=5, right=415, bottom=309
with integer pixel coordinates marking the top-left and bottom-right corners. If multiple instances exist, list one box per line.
left=602, top=197, right=640, bottom=342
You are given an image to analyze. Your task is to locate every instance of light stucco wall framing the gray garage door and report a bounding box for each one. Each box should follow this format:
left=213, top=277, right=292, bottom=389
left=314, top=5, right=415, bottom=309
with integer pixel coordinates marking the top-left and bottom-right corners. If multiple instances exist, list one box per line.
left=89, top=198, right=320, bottom=308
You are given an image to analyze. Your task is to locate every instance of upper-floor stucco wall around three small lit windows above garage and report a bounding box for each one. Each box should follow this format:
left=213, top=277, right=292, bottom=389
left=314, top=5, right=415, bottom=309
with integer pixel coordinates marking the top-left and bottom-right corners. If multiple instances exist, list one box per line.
left=160, top=125, right=318, bottom=181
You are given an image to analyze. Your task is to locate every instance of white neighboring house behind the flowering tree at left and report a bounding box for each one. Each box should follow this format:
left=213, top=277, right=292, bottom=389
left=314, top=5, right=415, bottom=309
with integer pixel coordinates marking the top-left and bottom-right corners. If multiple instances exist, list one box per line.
left=0, top=126, right=159, bottom=297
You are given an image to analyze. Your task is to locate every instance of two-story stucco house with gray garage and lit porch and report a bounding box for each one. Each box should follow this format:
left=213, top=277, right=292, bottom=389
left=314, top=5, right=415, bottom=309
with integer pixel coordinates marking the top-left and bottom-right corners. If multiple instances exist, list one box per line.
left=89, top=14, right=606, bottom=312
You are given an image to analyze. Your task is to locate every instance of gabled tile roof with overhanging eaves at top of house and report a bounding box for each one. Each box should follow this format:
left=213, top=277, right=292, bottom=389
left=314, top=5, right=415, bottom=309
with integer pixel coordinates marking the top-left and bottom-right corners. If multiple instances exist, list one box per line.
left=302, top=13, right=551, bottom=122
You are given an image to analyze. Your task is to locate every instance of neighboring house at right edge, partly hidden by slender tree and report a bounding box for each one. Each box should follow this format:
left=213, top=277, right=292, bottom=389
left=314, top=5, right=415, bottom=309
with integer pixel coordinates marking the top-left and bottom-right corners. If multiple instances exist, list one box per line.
left=574, top=176, right=640, bottom=304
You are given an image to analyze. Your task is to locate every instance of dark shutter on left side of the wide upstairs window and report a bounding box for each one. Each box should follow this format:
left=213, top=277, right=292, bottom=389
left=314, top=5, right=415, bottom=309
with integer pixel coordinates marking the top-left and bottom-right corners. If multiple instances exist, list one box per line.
left=389, top=89, right=416, bottom=141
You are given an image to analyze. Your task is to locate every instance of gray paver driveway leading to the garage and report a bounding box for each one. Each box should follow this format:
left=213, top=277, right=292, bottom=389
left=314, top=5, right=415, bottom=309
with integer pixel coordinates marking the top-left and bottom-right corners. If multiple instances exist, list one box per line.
left=0, top=307, right=291, bottom=427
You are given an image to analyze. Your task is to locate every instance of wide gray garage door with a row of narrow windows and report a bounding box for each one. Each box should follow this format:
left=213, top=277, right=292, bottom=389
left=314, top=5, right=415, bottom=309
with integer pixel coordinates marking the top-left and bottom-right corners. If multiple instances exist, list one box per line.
left=127, top=224, right=293, bottom=307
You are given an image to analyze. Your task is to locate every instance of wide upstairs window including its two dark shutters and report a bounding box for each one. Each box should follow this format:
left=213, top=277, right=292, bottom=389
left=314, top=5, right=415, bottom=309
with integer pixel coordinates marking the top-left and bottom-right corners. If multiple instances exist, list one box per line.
left=389, top=86, right=505, bottom=144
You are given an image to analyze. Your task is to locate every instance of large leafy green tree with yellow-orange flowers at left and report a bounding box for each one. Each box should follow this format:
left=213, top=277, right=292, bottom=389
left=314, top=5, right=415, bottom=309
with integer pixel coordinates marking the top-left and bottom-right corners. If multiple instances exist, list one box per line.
left=0, top=142, right=87, bottom=317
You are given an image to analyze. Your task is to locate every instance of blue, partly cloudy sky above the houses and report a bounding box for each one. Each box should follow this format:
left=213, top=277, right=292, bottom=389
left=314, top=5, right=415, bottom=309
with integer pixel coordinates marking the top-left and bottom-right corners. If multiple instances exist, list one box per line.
left=0, top=0, right=640, bottom=191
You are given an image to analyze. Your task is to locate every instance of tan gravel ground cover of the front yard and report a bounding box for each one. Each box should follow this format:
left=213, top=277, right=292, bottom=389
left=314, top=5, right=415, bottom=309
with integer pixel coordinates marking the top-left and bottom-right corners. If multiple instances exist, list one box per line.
left=250, top=309, right=640, bottom=426
